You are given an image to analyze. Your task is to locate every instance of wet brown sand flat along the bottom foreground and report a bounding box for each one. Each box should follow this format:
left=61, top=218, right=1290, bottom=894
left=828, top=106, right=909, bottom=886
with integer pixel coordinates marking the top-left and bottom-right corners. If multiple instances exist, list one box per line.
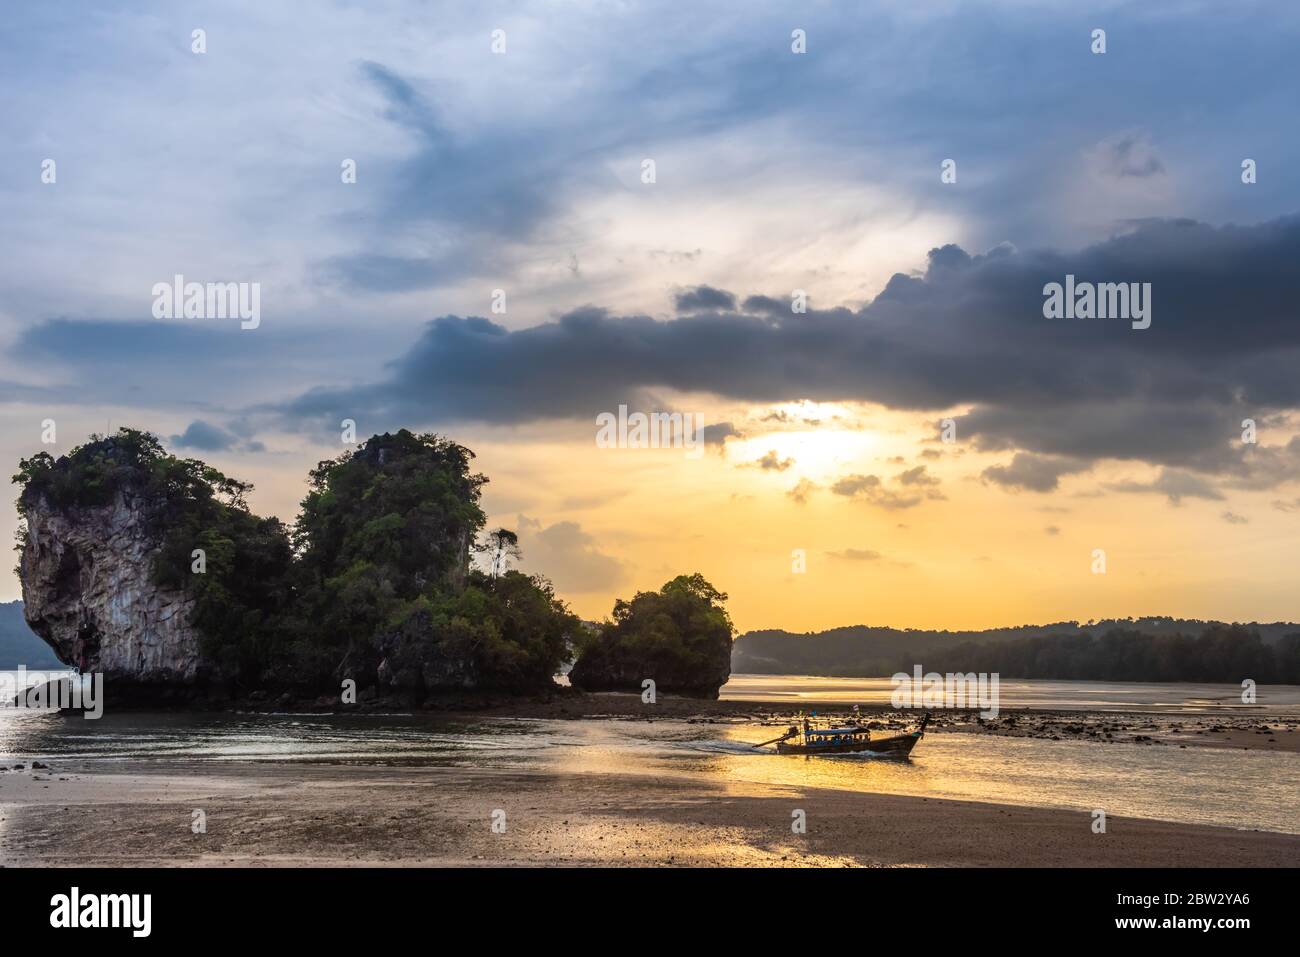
left=0, top=762, right=1300, bottom=867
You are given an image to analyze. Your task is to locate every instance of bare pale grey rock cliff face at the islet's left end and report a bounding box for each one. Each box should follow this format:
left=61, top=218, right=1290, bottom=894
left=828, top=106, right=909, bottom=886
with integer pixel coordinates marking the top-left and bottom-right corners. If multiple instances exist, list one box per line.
left=20, top=492, right=204, bottom=685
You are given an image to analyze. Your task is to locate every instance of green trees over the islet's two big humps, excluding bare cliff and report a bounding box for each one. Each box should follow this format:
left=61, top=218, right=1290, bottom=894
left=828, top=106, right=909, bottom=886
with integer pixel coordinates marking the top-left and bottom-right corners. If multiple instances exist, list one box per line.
left=14, top=429, right=580, bottom=694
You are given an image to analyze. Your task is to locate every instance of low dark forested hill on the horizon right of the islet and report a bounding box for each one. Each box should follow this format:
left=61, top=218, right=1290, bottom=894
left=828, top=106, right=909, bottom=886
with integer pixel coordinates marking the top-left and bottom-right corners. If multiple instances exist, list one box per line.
left=732, top=618, right=1300, bottom=684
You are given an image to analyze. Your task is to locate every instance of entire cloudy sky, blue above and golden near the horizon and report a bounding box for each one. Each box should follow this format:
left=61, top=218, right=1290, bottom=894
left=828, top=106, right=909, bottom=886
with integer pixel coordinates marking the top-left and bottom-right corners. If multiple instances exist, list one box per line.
left=0, top=0, right=1300, bottom=631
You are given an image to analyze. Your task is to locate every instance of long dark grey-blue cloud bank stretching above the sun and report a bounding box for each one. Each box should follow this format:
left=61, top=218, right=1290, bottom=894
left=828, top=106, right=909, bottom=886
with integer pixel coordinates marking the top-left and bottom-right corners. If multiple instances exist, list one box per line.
left=289, top=217, right=1300, bottom=489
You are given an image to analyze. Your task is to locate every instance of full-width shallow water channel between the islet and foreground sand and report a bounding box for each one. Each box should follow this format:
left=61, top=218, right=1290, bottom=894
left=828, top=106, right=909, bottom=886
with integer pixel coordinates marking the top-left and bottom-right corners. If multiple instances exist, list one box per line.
left=0, top=713, right=1300, bottom=833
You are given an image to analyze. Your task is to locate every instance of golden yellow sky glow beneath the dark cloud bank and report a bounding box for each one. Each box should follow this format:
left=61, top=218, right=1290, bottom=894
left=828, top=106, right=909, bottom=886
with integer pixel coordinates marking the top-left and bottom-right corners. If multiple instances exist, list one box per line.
left=10, top=395, right=1300, bottom=631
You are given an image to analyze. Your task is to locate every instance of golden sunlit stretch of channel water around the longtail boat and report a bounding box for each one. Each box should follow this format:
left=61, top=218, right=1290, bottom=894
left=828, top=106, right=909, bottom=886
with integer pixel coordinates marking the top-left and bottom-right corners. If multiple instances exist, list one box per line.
left=530, top=720, right=1300, bottom=833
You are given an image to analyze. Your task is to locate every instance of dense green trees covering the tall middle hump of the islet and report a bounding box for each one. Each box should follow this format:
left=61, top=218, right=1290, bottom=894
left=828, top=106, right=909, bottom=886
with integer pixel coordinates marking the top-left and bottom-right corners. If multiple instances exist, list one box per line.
left=284, top=429, right=577, bottom=692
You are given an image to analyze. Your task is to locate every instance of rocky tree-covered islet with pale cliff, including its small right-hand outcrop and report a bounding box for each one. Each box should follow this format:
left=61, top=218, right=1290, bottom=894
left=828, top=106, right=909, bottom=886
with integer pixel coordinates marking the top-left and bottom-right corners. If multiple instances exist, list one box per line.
left=14, top=428, right=735, bottom=707
